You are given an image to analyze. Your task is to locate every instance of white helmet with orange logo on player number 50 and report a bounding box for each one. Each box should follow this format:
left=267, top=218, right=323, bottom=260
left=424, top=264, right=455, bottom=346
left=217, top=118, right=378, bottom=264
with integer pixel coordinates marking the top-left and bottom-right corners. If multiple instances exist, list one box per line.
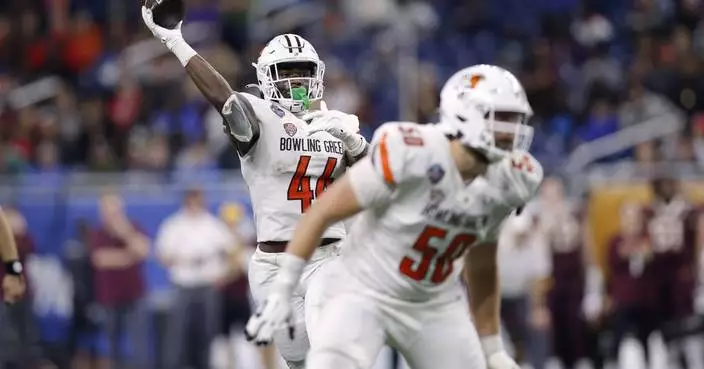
left=440, top=64, right=533, bottom=162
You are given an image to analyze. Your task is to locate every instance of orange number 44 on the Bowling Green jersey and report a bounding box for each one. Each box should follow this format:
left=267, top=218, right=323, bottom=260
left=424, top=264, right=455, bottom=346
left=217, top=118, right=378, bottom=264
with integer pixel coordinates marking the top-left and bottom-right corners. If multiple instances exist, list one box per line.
left=288, top=155, right=337, bottom=213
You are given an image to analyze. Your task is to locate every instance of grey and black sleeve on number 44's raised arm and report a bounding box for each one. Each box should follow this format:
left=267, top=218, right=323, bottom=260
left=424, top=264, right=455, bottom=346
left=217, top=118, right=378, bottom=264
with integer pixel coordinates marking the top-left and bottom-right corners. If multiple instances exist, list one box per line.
left=221, top=92, right=261, bottom=156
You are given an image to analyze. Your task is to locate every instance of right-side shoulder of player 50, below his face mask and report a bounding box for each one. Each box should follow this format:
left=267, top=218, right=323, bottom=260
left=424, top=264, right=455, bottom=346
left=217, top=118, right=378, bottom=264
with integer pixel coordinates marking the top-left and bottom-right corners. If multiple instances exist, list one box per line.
left=490, top=152, right=543, bottom=207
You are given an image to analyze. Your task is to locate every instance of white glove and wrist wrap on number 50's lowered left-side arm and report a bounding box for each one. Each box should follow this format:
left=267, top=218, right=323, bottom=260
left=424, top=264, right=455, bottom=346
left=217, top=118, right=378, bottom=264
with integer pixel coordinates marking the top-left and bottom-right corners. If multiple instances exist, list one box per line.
left=244, top=253, right=307, bottom=345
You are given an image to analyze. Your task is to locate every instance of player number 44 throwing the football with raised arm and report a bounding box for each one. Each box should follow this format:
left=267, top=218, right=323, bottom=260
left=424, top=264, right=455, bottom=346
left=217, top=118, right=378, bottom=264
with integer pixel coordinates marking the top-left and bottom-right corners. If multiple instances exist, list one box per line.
left=142, top=7, right=368, bottom=369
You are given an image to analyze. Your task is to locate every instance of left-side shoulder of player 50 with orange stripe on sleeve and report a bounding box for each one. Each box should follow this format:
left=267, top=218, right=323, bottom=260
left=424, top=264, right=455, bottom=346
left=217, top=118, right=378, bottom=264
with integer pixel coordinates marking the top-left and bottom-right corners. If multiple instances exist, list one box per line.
left=371, top=122, right=425, bottom=187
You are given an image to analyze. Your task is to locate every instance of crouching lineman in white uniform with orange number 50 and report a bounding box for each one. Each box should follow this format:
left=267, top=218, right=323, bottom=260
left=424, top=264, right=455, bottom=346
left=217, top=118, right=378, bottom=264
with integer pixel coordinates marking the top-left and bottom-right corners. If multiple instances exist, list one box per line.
left=246, top=65, right=543, bottom=369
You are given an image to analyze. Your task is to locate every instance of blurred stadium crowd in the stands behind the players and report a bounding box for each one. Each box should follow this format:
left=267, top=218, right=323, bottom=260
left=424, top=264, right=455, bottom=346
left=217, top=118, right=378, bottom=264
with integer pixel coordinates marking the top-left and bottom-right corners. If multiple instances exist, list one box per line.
left=0, top=0, right=704, bottom=172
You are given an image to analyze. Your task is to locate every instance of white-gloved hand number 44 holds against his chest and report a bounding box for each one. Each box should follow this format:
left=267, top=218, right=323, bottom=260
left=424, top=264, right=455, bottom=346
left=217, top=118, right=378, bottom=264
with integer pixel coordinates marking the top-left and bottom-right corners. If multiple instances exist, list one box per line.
left=301, top=101, right=367, bottom=157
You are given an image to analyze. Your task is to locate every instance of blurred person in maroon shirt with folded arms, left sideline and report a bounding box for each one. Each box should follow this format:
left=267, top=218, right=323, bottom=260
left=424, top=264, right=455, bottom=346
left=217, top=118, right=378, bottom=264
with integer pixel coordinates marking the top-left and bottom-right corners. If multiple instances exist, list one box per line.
left=89, top=191, right=151, bottom=369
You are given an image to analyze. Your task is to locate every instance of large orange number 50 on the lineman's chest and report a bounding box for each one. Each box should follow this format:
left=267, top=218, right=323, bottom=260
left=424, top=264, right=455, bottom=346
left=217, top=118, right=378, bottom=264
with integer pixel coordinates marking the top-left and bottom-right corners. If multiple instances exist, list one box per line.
left=399, top=226, right=477, bottom=284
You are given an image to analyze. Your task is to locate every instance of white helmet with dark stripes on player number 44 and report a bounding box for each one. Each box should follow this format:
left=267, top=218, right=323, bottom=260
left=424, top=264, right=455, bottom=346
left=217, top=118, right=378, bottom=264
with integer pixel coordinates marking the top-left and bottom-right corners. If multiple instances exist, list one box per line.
left=252, top=34, right=325, bottom=113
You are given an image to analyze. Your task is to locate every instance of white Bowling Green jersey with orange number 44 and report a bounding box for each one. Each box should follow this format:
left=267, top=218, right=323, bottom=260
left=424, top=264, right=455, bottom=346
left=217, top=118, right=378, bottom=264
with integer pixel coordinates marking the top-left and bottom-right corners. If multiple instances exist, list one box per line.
left=239, top=93, right=346, bottom=242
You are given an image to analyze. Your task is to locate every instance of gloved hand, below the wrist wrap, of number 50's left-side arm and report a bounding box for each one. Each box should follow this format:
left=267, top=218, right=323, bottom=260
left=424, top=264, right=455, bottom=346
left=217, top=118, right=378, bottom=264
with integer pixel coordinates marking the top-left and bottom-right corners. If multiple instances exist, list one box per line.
left=244, top=292, right=295, bottom=346
